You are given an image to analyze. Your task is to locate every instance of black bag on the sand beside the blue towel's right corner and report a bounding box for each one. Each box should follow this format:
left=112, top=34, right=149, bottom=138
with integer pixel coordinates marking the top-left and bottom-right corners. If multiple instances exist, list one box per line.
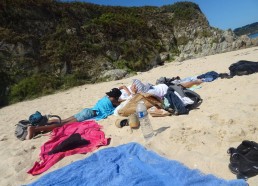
left=228, top=140, right=258, bottom=180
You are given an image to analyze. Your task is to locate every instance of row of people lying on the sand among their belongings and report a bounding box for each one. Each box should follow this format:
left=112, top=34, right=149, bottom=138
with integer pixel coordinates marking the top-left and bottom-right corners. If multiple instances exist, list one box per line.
left=26, top=78, right=203, bottom=139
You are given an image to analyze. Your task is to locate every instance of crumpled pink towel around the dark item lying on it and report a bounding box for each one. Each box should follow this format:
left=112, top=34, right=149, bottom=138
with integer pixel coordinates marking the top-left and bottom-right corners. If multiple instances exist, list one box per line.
left=28, top=120, right=109, bottom=175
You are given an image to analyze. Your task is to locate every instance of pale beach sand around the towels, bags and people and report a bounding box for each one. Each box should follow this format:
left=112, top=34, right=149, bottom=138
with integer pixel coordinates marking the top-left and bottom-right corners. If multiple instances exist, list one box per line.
left=0, top=47, right=258, bottom=186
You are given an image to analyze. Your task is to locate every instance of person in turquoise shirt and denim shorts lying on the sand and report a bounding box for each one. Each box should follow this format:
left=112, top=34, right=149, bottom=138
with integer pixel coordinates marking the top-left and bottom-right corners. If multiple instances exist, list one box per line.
left=26, top=88, right=122, bottom=139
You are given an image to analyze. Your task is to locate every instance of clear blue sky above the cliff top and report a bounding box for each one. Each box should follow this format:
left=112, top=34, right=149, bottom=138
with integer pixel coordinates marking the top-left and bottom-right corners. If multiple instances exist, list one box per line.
left=63, top=0, right=258, bottom=30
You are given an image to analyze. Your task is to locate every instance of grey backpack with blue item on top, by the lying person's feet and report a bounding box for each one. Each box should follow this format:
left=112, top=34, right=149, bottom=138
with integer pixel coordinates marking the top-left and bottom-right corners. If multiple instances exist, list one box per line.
left=14, top=111, right=61, bottom=141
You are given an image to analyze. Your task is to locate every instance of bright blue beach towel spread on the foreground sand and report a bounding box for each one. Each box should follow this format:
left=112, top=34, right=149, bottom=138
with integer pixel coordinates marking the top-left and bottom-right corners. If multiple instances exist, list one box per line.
left=27, top=143, right=247, bottom=186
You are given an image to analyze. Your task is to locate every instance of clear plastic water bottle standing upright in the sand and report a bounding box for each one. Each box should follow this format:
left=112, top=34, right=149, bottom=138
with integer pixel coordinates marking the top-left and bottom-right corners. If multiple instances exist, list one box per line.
left=136, top=101, right=154, bottom=141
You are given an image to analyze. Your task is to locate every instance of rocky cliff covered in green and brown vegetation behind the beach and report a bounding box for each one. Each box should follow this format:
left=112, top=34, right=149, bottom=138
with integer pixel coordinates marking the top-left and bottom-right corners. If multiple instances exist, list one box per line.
left=0, top=0, right=257, bottom=105
